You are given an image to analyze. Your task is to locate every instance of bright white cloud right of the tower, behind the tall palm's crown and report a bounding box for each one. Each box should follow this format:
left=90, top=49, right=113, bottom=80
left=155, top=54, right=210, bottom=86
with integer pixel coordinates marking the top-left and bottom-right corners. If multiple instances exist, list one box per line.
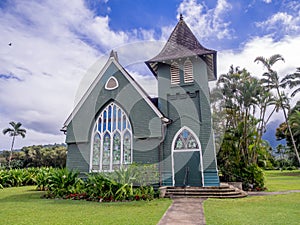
left=218, top=35, right=300, bottom=105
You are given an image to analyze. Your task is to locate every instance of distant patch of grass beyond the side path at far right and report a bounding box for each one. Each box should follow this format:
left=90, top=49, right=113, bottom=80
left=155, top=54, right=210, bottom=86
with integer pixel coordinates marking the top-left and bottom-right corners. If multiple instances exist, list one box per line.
left=265, top=170, right=300, bottom=191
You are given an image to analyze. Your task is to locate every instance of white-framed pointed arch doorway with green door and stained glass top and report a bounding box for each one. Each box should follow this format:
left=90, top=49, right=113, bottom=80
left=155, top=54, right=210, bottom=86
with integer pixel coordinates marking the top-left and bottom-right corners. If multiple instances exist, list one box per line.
left=172, top=127, right=204, bottom=186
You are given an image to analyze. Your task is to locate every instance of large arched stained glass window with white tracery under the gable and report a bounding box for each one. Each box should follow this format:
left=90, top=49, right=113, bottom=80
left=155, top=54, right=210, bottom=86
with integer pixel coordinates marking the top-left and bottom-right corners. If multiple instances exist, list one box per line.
left=91, top=102, right=132, bottom=171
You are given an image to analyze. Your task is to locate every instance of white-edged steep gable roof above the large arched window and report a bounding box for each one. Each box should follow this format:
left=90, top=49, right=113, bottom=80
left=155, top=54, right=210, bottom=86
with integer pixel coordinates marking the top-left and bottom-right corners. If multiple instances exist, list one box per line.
left=61, top=51, right=168, bottom=132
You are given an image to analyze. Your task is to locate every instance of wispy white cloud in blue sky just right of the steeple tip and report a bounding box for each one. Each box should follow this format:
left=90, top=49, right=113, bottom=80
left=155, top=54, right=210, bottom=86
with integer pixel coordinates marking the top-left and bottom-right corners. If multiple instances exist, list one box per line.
left=177, top=0, right=232, bottom=39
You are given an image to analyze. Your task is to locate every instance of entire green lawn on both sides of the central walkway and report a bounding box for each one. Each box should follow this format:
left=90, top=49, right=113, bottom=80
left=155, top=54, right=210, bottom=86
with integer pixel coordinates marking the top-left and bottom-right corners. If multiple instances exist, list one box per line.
left=0, top=171, right=300, bottom=225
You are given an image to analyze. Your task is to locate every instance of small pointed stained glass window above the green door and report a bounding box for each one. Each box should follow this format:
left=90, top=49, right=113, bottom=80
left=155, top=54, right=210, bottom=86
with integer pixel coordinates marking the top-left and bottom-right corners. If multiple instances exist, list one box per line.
left=174, top=129, right=199, bottom=150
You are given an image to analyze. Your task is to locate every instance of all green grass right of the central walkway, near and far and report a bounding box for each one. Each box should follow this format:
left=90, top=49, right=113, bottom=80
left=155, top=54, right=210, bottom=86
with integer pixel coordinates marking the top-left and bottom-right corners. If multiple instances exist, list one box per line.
left=204, top=170, right=300, bottom=225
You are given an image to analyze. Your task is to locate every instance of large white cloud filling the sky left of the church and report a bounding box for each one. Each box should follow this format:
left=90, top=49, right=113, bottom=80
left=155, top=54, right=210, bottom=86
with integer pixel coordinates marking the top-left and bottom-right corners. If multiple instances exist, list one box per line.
left=0, top=0, right=160, bottom=150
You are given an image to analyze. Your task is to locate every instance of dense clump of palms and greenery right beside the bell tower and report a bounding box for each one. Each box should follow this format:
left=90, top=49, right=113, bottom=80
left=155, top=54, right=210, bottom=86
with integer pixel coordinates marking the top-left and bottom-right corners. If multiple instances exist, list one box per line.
left=211, top=66, right=278, bottom=189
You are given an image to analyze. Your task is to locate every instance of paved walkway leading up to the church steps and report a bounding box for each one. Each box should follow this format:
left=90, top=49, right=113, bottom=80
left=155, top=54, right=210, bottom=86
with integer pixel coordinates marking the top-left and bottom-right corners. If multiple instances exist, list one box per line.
left=158, top=198, right=206, bottom=225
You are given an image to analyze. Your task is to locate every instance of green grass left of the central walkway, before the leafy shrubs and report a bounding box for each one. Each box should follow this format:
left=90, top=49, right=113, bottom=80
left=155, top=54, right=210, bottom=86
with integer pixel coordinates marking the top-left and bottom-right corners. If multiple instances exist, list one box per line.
left=0, top=186, right=171, bottom=225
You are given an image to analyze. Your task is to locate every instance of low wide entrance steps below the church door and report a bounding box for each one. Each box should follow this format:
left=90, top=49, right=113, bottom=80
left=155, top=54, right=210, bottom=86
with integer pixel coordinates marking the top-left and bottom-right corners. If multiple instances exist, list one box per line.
left=159, top=183, right=247, bottom=198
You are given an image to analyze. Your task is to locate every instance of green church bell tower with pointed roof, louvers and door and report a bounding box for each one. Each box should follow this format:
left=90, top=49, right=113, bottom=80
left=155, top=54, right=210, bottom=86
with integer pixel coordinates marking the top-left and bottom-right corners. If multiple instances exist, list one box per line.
left=146, top=15, right=219, bottom=186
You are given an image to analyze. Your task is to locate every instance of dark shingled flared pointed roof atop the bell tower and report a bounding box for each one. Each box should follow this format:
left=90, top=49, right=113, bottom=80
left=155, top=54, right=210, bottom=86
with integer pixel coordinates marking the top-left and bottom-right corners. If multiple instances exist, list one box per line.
left=146, top=15, right=217, bottom=80
